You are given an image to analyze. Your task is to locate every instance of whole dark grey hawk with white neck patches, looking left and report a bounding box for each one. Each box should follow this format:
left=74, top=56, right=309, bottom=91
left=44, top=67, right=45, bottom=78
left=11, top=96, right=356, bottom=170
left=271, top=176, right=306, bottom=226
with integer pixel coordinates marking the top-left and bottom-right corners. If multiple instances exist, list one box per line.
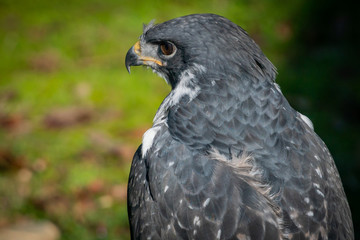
left=125, top=14, right=354, bottom=240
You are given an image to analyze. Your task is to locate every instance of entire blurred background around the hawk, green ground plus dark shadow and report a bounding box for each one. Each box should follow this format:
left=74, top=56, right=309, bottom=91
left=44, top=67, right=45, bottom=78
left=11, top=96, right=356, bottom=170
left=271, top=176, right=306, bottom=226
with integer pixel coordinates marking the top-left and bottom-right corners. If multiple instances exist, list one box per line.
left=0, top=0, right=360, bottom=239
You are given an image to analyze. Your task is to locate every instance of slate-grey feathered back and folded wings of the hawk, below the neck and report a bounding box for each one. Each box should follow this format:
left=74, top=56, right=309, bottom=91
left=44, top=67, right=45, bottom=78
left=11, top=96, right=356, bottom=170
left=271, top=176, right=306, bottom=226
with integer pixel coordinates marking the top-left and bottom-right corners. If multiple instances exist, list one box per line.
left=129, top=80, right=352, bottom=239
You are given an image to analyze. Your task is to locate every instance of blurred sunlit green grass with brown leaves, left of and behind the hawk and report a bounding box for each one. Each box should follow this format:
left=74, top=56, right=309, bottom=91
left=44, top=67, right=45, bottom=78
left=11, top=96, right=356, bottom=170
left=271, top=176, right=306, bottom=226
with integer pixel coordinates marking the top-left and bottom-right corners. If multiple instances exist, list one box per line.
left=0, top=0, right=306, bottom=239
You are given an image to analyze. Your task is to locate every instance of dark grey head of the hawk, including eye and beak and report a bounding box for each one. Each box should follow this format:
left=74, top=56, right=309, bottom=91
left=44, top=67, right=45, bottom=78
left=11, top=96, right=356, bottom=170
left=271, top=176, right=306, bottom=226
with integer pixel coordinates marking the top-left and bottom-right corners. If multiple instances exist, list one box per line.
left=125, top=14, right=276, bottom=89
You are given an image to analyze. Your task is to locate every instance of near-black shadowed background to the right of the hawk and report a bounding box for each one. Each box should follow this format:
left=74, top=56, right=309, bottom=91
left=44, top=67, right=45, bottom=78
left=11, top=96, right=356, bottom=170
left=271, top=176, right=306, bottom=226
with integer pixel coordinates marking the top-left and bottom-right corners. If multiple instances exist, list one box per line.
left=279, top=1, right=360, bottom=237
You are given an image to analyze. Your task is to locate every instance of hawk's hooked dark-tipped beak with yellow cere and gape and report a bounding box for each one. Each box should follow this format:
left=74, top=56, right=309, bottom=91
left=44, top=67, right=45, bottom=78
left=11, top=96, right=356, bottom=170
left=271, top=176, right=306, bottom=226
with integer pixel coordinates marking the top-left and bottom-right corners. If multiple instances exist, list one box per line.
left=125, top=41, right=163, bottom=73
